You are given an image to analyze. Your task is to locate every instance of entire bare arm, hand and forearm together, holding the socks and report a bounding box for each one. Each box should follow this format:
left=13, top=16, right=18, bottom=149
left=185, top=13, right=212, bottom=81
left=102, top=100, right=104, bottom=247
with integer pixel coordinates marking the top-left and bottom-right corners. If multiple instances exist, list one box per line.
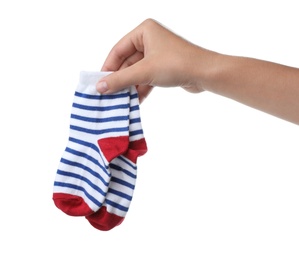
left=97, top=19, right=299, bottom=124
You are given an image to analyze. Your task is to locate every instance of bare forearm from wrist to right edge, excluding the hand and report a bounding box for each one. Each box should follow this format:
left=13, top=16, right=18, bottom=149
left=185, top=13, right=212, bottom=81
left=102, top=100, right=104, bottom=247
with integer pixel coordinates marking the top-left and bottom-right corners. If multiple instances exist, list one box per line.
left=203, top=54, right=299, bottom=124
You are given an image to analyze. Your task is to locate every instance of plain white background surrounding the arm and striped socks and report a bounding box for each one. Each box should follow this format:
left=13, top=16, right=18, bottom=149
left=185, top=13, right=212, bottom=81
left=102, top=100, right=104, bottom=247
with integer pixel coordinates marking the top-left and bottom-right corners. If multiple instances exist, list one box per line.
left=0, top=0, right=299, bottom=260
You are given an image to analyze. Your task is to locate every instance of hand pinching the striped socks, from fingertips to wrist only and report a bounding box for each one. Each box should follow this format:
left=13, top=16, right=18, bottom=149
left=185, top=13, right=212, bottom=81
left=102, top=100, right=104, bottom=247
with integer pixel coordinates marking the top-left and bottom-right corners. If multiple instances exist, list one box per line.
left=97, top=19, right=211, bottom=102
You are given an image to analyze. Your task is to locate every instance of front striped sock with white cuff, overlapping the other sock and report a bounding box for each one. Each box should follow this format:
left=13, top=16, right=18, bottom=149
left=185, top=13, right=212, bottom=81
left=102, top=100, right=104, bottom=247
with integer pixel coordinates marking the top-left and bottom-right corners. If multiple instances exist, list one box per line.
left=53, top=72, right=130, bottom=216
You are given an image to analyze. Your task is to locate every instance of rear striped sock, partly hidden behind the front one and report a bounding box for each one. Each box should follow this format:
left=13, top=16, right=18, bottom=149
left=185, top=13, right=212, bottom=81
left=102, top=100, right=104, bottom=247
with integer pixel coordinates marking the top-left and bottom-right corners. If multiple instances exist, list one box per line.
left=86, top=87, right=147, bottom=231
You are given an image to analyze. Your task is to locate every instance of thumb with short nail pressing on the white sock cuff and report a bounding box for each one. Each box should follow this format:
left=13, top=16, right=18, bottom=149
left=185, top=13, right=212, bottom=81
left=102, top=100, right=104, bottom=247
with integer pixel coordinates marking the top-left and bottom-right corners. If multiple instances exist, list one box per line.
left=96, top=61, right=149, bottom=94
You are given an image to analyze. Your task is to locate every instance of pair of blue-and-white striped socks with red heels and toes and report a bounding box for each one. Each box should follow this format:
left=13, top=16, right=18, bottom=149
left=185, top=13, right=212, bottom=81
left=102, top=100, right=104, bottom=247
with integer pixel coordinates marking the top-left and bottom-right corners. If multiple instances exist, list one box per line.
left=53, top=72, right=147, bottom=231
